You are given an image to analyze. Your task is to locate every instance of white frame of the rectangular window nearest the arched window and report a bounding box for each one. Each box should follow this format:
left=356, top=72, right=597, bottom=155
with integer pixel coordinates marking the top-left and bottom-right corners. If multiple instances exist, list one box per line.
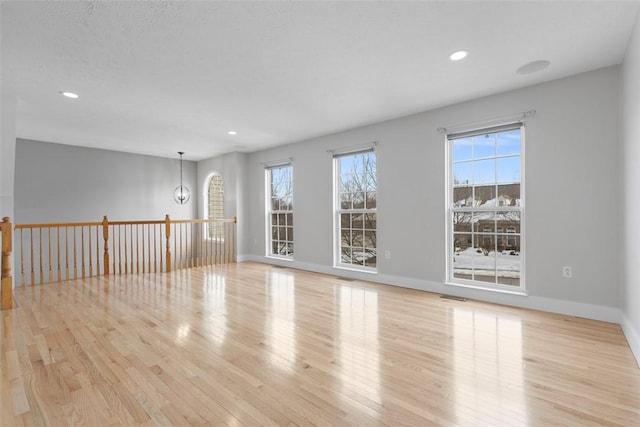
left=264, top=162, right=295, bottom=261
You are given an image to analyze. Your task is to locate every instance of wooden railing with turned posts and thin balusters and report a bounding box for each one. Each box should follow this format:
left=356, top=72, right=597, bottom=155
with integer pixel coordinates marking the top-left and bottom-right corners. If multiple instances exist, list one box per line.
left=2, top=215, right=237, bottom=309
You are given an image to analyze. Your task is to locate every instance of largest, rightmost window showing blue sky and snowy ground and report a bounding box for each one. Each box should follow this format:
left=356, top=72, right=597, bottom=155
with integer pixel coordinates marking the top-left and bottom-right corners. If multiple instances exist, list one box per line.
left=447, top=123, right=524, bottom=290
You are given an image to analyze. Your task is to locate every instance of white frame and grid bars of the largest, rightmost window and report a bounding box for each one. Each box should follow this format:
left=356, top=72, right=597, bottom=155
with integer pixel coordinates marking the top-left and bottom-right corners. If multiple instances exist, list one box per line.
left=444, top=121, right=526, bottom=295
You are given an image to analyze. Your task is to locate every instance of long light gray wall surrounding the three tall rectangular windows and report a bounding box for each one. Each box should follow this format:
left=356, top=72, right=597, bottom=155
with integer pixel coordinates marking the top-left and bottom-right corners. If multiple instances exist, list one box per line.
left=247, top=67, right=620, bottom=321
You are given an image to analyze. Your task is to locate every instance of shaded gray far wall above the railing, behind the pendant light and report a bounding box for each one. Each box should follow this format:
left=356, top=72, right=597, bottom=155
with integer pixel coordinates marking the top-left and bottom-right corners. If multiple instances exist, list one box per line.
left=14, top=139, right=199, bottom=223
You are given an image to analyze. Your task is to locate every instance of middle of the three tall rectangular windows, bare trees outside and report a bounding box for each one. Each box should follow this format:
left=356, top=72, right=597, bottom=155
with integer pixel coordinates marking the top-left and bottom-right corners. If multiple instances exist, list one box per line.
left=334, top=150, right=377, bottom=271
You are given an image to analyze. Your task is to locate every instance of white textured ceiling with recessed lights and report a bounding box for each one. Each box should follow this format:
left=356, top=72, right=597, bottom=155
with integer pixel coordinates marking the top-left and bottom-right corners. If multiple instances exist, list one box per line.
left=1, top=1, right=640, bottom=160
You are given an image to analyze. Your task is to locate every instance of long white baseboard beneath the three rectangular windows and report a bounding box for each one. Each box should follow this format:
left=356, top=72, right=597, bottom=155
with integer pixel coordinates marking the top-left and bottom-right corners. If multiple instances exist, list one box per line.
left=238, top=255, right=620, bottom=324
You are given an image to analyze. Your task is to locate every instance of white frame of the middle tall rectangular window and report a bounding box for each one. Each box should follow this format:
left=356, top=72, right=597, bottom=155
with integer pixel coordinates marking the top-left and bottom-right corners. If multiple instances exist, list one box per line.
left=332, top=147, right=378, bottom=273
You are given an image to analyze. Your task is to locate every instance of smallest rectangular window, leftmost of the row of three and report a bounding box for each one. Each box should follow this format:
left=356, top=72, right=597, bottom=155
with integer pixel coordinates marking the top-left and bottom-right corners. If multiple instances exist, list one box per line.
left=266, top=164, right=293, bottom=259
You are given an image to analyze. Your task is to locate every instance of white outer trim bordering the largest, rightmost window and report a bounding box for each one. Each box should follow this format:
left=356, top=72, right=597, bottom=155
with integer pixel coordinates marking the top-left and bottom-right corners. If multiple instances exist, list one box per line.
left=444, top=120, right=527, bottom=296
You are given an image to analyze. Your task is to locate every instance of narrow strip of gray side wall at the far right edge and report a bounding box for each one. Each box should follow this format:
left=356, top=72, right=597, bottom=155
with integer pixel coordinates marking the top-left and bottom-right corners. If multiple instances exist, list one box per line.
left=621, top=10, right=640, bottom=365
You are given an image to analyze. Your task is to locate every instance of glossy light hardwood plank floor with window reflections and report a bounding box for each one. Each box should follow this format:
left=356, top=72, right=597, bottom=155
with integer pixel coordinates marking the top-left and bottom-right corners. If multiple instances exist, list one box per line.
left=0, top=263, right=640, bottom=427
